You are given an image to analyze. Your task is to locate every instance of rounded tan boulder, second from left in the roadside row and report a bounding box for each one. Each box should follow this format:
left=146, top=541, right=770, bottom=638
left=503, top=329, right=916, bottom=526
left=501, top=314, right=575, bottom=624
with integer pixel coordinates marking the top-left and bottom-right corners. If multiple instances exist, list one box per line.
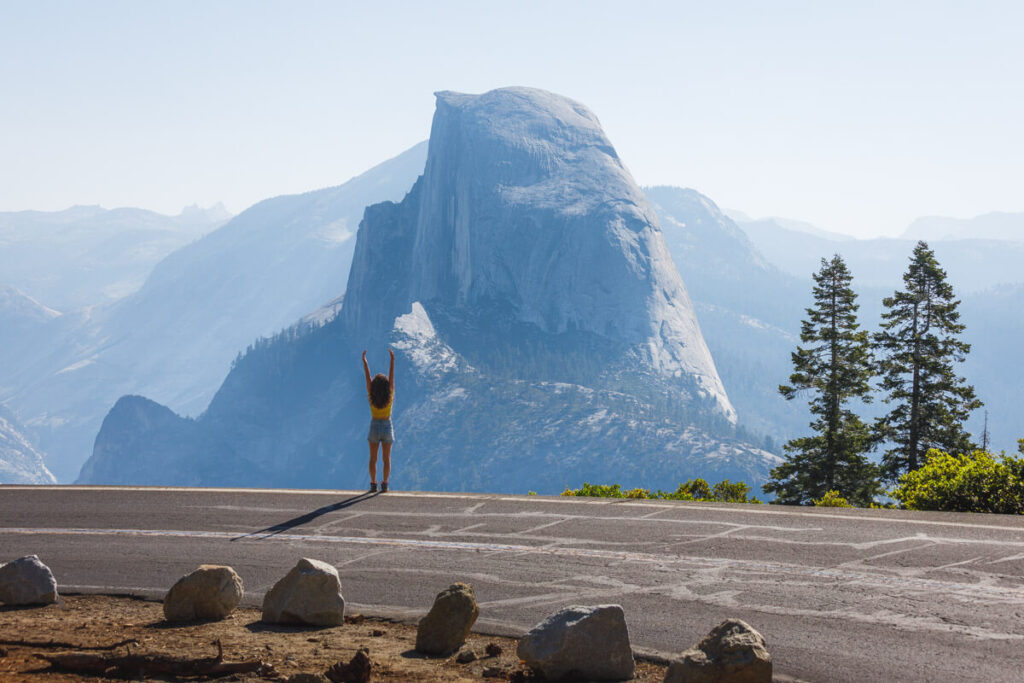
left=164, top=564, right=244, bottom=622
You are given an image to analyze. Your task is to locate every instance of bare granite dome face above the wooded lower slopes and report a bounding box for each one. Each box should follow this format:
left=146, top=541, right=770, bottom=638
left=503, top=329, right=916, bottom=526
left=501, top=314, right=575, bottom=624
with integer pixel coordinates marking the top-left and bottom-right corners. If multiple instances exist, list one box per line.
left=342, top=88, right=735, bottom=421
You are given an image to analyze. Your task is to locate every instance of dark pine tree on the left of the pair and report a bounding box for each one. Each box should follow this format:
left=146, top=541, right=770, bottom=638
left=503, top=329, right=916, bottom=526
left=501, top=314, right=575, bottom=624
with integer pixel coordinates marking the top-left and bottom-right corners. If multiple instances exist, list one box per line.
left=764, top=254, right=881, bottom=505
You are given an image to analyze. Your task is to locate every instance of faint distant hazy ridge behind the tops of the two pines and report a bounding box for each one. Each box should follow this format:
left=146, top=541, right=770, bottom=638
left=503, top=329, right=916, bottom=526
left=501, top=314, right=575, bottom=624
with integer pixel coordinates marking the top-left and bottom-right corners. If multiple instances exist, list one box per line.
left=738, top=219, right=1024, bottom=293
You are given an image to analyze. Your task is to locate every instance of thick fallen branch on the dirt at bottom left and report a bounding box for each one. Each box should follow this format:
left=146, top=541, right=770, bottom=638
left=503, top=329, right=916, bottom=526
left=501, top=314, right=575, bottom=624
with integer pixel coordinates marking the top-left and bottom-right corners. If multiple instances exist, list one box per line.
left=36, top=640, right=276, bottom=680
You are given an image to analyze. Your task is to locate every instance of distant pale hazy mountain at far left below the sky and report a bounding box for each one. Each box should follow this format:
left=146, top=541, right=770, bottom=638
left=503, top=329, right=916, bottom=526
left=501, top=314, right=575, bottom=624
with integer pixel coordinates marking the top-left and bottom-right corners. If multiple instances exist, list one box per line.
left=0, top=205, right=230, bottom=311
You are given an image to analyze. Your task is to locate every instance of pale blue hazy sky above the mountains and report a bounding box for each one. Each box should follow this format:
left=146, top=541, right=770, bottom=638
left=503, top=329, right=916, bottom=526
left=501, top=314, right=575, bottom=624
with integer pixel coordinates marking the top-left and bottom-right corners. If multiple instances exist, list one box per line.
left=0, top=0, right=1024, bottom=237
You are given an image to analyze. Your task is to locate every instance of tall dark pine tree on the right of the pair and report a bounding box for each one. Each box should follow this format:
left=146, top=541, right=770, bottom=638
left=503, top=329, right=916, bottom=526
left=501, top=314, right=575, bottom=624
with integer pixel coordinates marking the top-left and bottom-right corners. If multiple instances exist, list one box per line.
left=874, top=242, right=982, bottom=480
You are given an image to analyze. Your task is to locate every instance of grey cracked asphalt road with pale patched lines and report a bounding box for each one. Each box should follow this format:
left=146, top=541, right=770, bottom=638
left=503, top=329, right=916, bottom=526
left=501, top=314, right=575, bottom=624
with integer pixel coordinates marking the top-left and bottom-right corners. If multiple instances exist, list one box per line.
left=0, top=486, right=1024, bottom=681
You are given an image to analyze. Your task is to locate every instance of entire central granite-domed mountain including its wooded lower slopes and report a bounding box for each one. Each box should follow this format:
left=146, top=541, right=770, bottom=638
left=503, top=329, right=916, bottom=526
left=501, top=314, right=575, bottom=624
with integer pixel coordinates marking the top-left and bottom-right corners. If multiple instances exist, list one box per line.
left=81, top=88, right=778, bottom=493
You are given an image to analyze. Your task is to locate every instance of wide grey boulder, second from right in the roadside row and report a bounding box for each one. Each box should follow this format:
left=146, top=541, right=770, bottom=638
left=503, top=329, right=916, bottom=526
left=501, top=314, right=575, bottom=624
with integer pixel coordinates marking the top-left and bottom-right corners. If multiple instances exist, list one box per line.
left=516, top=605, right=636, bottom=681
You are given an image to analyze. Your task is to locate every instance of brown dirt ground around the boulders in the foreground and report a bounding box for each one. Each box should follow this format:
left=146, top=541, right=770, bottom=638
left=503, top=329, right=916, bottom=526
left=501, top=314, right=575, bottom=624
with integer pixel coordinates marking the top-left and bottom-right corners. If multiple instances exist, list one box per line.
left=0, top=596, right=666, bottom=683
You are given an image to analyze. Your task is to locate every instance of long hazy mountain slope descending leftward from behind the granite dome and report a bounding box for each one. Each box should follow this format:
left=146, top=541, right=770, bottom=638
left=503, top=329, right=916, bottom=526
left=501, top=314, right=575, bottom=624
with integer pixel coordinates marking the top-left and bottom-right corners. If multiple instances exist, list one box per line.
left=0, top=143, right=426, bottom=481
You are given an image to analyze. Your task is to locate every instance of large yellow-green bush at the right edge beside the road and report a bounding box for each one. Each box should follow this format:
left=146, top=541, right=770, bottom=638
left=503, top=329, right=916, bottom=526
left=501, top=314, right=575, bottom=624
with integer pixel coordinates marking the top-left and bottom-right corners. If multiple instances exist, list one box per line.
left=892, top=446, right=1024, bottom=514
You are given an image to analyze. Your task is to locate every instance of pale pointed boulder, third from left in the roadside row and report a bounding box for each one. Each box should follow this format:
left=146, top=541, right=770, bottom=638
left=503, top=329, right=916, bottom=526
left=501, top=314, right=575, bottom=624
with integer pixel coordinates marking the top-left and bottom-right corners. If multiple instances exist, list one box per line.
left=263, top=558, right=345, bottom=626
